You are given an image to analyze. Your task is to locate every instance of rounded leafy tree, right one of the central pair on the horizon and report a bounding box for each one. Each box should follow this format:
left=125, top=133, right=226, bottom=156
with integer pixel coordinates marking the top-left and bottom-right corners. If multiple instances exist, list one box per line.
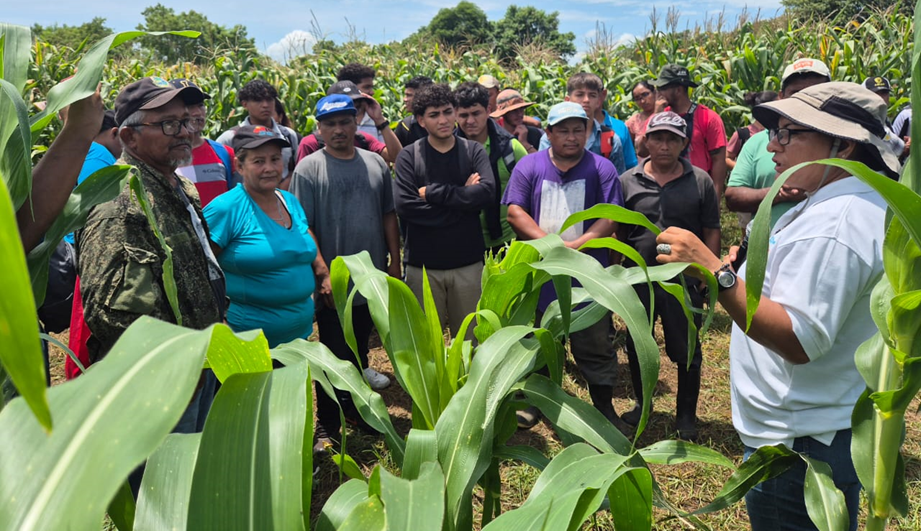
left=493, top=5, right=576, bottom=59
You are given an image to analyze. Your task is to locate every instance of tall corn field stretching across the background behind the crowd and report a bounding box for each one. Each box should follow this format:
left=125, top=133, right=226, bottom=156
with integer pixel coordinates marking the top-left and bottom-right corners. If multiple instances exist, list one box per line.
left=27, top=10, right=913, bottom=145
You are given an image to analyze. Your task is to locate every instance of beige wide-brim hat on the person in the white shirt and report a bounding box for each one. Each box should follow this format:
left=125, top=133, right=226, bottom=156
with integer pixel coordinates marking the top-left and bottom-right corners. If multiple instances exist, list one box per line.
left=752, top=82, right=901, bottom=177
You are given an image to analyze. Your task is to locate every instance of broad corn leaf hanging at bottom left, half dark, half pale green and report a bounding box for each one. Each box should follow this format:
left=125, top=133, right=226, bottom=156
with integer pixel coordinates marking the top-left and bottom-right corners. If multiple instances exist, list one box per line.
left=188, top=362, right=312, bottom=530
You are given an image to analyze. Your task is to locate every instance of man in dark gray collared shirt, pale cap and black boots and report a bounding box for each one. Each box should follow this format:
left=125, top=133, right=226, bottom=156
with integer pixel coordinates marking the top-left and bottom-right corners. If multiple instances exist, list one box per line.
left=618, top=112, right=720, bottom=440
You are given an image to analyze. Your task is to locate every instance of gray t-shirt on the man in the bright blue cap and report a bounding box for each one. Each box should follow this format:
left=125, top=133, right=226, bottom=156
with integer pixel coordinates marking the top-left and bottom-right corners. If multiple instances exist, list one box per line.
left=290, top=149, right=393, bottom=280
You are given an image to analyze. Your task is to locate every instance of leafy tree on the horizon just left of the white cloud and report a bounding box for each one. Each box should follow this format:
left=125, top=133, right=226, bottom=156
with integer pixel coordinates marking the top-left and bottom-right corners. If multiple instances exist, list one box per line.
left=137, top=4, right=256, bottom=63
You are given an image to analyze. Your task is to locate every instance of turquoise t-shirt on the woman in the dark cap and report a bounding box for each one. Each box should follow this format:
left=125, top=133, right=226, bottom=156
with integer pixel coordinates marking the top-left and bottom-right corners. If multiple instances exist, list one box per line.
left=204, top=184, right=317, bottom=347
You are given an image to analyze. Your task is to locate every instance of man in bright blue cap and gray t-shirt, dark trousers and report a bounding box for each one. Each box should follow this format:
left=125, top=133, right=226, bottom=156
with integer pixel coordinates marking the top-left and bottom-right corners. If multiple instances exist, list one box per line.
left=290, top=94, right=402, bottom=451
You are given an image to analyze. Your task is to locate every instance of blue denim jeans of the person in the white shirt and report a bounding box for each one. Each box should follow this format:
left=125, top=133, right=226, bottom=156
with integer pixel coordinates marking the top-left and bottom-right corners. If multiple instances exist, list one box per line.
left=745, top=429, right=860, bottom=531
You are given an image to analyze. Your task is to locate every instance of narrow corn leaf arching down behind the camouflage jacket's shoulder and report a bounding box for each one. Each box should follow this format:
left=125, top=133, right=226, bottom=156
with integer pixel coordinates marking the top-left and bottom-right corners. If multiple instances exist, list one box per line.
left=28, top=165, right=132, bottom=306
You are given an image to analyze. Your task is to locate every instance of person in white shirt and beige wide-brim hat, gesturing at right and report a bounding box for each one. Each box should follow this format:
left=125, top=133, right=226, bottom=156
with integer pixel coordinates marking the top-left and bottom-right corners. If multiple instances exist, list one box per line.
left=657, top=83, right=900, bottom=531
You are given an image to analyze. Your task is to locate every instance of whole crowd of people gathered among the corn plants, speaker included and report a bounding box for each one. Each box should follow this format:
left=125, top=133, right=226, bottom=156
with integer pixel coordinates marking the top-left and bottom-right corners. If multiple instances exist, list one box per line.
left=18, top=59, right=911, bottom=530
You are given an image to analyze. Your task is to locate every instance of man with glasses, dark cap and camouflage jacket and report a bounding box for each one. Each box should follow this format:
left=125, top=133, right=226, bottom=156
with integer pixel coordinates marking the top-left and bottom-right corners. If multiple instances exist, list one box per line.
left=78, top=78, right=225, bottom=368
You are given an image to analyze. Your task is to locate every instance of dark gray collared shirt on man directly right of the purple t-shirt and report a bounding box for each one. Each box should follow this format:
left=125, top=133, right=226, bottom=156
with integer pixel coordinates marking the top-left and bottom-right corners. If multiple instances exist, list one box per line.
left=620, top=158, right=720, bottom=265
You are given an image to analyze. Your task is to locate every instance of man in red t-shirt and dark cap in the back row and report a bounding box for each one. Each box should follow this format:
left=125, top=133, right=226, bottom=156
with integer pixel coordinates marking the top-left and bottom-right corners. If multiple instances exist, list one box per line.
left=640, top=64, right=727, bottom=198
